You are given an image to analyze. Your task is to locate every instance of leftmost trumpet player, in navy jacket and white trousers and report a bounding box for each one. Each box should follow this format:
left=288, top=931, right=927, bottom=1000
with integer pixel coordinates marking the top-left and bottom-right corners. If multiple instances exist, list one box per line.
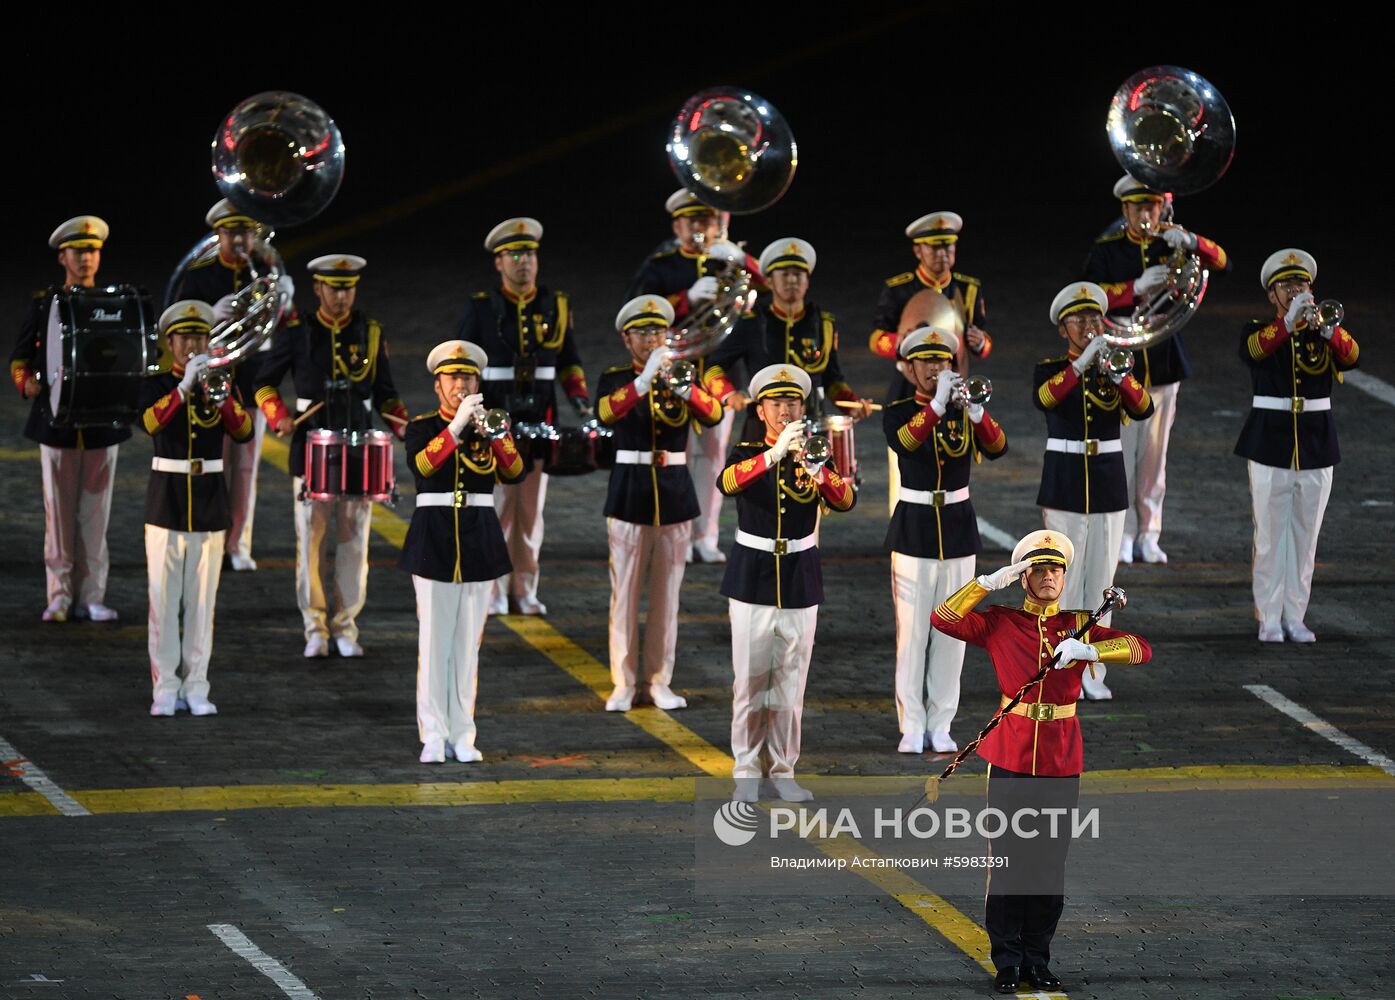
left=141, top=300, right=252, bottom=715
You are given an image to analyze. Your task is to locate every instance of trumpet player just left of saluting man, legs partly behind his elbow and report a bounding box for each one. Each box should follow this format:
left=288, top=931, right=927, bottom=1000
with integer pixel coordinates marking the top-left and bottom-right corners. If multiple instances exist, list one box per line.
left=882, top=326, right=1007, bottom=753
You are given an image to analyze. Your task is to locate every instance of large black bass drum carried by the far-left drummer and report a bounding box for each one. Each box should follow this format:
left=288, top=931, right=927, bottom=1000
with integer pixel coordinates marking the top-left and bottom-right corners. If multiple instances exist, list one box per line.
left=43, top=285, right=160, bottom=428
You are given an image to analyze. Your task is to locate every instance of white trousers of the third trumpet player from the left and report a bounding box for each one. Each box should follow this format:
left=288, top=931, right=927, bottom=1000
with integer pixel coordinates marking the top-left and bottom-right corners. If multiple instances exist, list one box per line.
left=605, top=517, right=692, bottom=690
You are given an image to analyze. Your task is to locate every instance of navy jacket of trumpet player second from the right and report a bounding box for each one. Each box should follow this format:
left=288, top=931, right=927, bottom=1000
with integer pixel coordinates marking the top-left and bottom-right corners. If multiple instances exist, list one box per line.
left=1032, top=354, right=1152, bottom=513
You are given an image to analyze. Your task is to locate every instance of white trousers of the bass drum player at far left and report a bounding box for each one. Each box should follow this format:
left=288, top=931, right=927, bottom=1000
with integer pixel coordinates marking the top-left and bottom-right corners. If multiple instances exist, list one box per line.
left=39, top=445, right=119, bottom=605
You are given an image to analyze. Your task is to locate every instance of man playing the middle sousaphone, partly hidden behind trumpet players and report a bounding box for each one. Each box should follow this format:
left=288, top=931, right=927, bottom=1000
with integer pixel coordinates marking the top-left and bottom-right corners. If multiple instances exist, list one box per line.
left=628, top=188, right=760, bottom=562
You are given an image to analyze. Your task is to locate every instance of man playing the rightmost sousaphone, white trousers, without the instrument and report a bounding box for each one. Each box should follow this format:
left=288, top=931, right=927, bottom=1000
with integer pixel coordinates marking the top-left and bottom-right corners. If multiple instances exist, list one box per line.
left=1084, top=174, right=1230, bottom=562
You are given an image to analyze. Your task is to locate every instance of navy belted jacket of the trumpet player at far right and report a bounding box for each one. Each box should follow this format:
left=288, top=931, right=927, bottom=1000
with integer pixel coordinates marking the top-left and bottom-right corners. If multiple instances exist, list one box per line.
left=1235, top=317, right=1360, bottom=469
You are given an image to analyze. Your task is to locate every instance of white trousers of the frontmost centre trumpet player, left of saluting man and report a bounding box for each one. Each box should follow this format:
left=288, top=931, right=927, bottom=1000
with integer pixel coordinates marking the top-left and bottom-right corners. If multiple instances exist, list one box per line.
left=727, top=600, right=819, bottom=778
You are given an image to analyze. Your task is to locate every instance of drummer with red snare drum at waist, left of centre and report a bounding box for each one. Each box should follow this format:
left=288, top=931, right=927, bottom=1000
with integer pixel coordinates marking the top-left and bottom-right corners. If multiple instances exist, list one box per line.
left=257, top=254, right=407, bottom=657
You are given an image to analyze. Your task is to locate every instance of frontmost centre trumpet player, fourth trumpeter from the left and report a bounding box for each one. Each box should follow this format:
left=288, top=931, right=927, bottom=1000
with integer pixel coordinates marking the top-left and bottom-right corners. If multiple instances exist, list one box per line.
left=720, top=364, right=857, bottom=802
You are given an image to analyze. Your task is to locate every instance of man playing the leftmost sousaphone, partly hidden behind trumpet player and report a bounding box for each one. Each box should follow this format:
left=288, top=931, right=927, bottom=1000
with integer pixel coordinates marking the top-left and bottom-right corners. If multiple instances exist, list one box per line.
left=170, top=198, right=300, bottom=572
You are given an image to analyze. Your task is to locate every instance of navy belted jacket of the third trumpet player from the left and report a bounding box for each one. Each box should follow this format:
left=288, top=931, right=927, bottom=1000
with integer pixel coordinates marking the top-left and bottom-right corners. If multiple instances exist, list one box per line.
left=596, top=363, right=721, bottom=524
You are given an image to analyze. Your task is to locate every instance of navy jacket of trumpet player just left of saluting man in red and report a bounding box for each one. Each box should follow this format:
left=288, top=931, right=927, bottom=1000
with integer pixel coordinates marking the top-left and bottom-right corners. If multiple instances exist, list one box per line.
left=882, top=392, right=1007, bottom=559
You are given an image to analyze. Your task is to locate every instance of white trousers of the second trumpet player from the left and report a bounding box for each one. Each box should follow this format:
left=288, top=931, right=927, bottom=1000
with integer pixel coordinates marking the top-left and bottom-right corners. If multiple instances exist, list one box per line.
left=412, top=576, right=494, bottom=746
